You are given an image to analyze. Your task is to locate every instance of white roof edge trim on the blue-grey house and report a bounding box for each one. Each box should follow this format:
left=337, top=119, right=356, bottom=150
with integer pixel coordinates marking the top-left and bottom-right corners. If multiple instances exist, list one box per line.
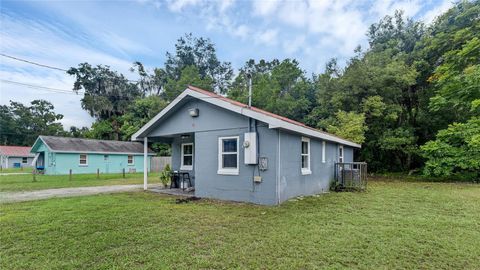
left=132, top=88, right=362, bottom=148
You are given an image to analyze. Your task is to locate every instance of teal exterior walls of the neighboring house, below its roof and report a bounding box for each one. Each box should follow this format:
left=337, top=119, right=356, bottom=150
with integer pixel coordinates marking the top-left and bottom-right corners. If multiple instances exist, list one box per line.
left=32, top=138, right=151, bottom=175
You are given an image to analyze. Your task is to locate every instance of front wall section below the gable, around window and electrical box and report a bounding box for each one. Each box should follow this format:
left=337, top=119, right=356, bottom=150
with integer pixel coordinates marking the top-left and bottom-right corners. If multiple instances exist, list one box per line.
left=195, top=126, right=277, bottom=205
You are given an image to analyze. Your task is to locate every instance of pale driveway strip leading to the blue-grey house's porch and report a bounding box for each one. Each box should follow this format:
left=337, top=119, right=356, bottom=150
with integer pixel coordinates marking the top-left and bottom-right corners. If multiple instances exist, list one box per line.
left=0, top=184, right=162, bottom=203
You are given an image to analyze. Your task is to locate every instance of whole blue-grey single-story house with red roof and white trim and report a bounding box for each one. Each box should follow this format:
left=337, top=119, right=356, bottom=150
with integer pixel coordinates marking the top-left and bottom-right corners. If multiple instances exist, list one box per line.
left=132, top=86, right=360, bottom=205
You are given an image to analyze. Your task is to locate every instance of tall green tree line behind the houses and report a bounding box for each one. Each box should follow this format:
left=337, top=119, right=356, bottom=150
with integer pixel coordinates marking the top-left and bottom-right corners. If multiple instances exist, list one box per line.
left=1, top=0, right=480, bottom=179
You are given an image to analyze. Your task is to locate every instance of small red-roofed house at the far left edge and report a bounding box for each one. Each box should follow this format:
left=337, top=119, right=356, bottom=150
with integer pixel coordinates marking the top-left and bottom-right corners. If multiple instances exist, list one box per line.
left=0, top=145, right=34, bottom=168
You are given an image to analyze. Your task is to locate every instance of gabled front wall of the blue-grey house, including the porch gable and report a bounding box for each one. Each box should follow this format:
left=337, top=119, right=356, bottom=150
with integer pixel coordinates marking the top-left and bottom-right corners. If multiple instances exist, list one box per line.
left=149, top=99, right=277, bottom=205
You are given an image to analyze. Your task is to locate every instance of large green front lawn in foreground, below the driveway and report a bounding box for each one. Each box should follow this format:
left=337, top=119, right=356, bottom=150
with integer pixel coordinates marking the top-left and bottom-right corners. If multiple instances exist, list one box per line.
left=0, top=181, right=480, bottom=269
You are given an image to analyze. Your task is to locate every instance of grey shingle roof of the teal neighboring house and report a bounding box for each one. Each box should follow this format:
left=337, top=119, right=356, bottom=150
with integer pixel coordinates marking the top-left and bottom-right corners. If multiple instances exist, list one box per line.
left=39, top=136, right=154, bottom=154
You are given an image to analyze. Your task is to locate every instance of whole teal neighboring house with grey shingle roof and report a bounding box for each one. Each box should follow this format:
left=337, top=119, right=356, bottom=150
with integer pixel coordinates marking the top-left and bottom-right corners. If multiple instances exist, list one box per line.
left=31, top=136, right=155, bottom=174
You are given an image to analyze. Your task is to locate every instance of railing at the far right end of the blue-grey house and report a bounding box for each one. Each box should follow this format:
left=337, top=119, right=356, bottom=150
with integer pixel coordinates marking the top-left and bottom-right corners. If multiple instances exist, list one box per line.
left=334, top=162, right=367, bottom=191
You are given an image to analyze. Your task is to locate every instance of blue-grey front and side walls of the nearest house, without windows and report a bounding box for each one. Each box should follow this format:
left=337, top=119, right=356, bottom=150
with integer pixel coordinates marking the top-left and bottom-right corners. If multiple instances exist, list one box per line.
left=148, top=98, right=353, bottom=205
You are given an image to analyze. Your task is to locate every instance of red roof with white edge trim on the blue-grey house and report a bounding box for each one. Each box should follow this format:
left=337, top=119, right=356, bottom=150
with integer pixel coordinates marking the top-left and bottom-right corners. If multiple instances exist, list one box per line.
left=132, top=86, right=361, bottom=148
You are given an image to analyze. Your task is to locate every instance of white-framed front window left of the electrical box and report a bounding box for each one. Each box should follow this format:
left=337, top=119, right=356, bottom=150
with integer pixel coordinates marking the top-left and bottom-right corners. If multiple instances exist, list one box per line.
left=218, top=136, right=239, bottom=175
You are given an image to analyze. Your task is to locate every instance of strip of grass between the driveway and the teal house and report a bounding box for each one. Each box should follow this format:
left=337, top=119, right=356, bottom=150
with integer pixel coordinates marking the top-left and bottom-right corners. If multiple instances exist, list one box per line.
left=0, top=173, right=160, bottom=192
